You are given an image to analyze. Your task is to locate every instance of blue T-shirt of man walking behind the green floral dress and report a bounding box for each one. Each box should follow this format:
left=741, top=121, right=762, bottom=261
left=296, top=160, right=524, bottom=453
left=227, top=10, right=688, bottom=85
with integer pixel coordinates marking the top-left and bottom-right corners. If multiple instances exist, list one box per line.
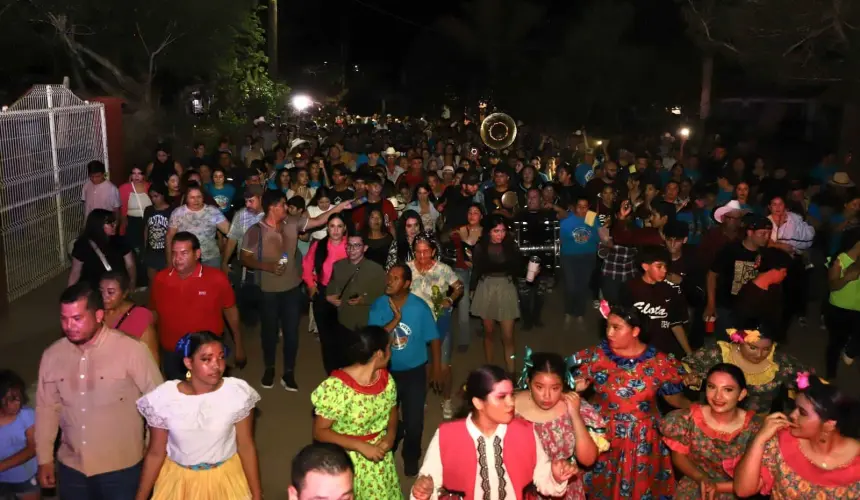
left=368, top=293, right=439, bottom=372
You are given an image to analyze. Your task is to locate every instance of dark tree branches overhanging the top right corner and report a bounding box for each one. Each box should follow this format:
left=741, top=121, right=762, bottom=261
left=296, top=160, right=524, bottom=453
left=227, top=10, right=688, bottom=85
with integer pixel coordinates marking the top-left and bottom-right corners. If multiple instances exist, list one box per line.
left=679, top=0, right=860, bottom=152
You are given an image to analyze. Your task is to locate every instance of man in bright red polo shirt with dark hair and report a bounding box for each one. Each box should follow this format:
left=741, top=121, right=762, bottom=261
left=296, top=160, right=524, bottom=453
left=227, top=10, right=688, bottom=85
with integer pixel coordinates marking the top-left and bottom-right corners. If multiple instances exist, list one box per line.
left=149, top=231, right=247, bottom=380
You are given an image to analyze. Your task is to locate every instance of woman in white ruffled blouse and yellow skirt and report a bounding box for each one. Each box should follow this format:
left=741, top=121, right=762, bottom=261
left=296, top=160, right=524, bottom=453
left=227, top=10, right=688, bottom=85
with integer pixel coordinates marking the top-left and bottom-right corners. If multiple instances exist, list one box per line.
left=136, top=332, right=263, bottom=500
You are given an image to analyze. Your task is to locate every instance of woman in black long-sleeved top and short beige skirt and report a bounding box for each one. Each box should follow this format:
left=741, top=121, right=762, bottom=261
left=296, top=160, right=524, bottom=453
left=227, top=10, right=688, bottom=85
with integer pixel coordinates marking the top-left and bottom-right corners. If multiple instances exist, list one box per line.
left=470, top=214, right=525, bottom=373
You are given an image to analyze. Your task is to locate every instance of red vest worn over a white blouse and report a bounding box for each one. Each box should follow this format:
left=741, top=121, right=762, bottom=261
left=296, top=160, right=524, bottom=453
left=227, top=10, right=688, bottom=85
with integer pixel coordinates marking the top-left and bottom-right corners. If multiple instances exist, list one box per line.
left=439, top=418, right=537, bottom=500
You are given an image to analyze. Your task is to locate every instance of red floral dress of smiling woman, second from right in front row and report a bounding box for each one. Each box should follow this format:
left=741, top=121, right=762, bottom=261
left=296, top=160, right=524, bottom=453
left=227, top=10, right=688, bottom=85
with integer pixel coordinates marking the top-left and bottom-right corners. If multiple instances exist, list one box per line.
left=660, top=405, right=763, bottom=500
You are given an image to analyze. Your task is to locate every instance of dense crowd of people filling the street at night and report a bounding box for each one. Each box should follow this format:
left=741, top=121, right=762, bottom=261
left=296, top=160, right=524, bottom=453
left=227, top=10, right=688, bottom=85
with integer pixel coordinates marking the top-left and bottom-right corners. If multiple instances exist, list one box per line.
left=0, top=113, right=860, bottom=500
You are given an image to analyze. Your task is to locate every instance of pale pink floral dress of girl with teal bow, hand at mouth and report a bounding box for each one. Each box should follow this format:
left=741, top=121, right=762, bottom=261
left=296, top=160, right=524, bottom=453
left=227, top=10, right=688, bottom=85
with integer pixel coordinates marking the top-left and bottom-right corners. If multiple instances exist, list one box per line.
left=526, top=401, right=609, bottom=500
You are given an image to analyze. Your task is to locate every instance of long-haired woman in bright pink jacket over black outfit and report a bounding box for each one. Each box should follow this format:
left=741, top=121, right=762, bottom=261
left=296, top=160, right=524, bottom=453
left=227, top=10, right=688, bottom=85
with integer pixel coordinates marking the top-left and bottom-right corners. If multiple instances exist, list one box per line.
left=302, top=213, right=347, bottom=374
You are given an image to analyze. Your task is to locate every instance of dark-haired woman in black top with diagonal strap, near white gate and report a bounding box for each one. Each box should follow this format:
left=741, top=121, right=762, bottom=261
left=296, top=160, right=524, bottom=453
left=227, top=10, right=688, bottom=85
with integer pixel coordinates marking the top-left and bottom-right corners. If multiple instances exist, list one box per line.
left=68, top=208, right=137, bottom=290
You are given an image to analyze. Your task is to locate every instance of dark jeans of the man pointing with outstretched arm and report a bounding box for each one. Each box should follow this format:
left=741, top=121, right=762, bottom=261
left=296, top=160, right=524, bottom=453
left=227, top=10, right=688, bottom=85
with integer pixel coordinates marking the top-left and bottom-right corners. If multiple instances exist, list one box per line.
left=260, top=286, right=304, bottom=372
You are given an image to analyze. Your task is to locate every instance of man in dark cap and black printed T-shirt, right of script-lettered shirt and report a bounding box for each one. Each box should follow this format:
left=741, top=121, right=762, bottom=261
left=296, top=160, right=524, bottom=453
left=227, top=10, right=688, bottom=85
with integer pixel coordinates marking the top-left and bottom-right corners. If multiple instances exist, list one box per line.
left=704, top=215, right=773, bottom=332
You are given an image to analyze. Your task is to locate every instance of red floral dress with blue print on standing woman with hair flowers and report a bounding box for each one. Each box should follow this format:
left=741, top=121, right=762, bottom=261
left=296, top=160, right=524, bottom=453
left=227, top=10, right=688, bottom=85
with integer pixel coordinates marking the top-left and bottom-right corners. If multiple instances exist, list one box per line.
left=576, top=341, right=683, bottom=500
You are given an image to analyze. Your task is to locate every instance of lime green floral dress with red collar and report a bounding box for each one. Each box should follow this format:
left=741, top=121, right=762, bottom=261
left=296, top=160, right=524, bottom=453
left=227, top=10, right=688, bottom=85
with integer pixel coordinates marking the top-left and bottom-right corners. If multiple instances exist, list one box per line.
left=311, top=370, right=403, bottom=500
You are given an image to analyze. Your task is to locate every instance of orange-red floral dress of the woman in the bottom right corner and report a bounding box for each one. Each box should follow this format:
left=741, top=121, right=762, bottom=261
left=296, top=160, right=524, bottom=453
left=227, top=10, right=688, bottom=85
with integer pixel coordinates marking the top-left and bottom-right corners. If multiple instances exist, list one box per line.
left=726, top=430, right=860, bottom=500
